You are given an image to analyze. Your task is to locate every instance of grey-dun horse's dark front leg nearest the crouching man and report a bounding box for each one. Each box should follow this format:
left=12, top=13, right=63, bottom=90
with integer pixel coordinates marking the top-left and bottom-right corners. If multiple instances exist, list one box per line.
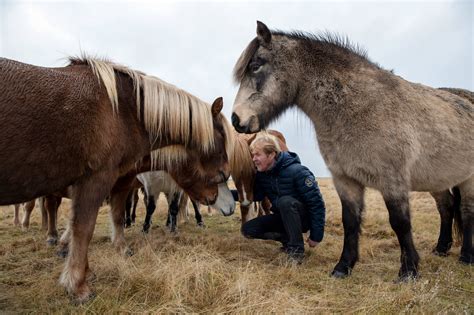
left=332, top=177, right=364, bottom=278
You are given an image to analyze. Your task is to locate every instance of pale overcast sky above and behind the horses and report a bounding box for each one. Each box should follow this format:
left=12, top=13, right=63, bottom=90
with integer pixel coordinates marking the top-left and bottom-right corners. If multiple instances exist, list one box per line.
left=0, top=0, right=474, bottom=177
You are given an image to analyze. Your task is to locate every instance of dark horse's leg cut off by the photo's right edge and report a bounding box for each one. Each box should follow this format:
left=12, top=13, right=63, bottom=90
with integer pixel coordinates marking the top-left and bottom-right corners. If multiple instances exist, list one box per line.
left=458, top=176, right=474, bottom=265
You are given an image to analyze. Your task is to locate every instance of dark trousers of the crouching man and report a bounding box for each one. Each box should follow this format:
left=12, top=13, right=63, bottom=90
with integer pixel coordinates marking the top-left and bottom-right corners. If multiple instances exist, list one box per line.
left=242, top=196, right=310, bottom=253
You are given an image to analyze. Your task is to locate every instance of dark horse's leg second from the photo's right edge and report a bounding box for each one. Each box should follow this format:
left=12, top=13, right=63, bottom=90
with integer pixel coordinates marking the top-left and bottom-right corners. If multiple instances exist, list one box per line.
left=431, top=190, right=454, bottom=256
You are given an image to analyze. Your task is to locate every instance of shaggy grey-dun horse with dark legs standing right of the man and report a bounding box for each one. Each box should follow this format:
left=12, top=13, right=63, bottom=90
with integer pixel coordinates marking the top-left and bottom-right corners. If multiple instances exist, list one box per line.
left=232, top=21, right=474, bottom=280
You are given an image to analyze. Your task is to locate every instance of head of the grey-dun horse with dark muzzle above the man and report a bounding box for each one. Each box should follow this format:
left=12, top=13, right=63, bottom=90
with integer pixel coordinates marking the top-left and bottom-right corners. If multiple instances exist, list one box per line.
left=232, top=21, right=297, bottom=133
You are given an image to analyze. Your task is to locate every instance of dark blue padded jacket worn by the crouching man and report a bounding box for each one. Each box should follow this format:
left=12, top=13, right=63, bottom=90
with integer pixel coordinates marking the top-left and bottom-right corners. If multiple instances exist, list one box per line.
left=254, top=152, right=326, bottom=242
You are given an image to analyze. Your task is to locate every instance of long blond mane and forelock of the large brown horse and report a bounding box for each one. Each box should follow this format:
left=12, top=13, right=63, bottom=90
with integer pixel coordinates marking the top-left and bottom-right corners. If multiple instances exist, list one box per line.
left=69, top=55, right=233, bottom=168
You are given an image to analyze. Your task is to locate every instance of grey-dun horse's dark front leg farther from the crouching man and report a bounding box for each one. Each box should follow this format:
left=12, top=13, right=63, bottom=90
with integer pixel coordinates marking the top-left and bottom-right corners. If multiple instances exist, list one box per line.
left=382, top=188, right=420, bottom=281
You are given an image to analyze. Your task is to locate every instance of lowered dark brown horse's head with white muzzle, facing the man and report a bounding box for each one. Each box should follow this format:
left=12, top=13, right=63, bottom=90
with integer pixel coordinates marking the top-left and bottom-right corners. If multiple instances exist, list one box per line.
left=167, top=97, right=235, bottom=216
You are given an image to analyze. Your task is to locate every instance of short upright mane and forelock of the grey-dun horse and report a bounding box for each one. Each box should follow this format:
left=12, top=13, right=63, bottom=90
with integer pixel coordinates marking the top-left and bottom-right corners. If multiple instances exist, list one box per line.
left=233, top=30, right=380, bottom=83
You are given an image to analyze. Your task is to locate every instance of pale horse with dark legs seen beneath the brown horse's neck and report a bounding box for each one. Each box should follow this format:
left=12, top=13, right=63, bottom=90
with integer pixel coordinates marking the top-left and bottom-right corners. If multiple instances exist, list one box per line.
left=137, top=171, right=204, bottom=233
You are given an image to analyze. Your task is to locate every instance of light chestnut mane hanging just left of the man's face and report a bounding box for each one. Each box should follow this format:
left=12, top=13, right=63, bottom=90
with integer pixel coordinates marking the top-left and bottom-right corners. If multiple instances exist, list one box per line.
left=229, top=131, right=255, bottom=181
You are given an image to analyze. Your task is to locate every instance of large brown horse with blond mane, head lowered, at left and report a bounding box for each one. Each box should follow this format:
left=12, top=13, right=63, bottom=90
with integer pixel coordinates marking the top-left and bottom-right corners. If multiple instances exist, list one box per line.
left=0, top=56, right=235, bottom=303
